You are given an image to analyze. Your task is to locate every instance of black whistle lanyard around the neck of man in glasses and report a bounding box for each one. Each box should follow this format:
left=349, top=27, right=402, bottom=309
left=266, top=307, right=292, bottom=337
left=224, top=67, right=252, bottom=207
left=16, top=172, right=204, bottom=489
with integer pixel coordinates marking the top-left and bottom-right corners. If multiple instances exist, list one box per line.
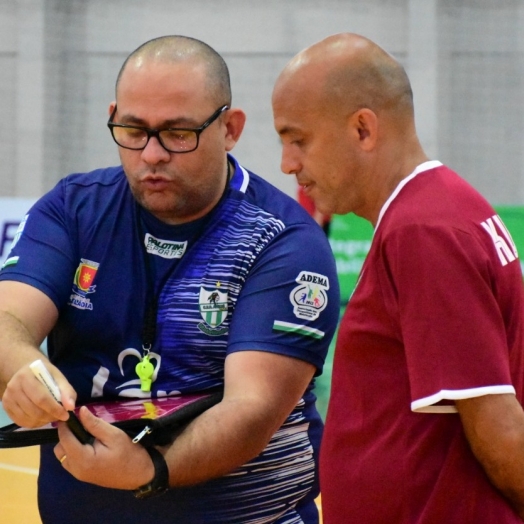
left=135, top=160, right=231, bottom=356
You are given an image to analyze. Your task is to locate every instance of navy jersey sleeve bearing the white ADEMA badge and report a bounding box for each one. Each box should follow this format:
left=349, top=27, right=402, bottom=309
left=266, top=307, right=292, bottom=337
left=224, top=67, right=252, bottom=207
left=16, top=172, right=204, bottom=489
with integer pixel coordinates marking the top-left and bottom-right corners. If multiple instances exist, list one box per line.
left=228, top=223, right=340, bottom=374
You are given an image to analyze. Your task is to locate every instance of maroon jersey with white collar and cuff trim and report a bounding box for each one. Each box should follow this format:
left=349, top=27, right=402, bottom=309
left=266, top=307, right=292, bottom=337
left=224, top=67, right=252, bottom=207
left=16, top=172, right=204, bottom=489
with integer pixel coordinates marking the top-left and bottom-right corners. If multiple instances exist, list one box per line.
left=320, top=162, right=524, bottom=524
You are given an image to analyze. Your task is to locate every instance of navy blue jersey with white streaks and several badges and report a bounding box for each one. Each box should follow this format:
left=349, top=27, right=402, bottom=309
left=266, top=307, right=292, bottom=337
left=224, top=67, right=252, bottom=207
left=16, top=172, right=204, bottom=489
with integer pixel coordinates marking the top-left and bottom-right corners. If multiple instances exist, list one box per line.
left=0, top=157, right=339, bottom=524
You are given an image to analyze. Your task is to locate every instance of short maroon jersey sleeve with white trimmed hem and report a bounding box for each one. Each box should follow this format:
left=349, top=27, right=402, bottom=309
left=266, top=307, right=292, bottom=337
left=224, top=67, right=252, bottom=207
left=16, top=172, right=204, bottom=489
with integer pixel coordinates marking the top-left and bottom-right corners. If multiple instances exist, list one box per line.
left=384, top=225, right=515, bottom=412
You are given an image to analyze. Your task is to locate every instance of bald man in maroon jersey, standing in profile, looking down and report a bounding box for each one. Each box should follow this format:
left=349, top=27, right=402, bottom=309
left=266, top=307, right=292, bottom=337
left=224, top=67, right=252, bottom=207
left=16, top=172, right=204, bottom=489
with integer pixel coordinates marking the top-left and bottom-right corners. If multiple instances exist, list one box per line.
left=273, top=34, right=524, bottom=524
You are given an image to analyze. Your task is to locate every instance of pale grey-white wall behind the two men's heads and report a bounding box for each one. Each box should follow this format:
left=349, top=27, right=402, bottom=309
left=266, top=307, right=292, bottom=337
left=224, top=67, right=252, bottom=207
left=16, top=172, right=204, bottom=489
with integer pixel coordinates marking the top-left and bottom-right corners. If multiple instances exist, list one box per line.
left=0, top=0, right=524, bottom=204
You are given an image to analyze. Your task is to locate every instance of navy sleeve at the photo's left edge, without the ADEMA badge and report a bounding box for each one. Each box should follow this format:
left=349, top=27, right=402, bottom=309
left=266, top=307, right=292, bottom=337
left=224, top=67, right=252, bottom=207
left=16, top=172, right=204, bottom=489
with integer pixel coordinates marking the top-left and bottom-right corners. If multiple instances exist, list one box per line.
left=0, top=183, right=75, bottom=309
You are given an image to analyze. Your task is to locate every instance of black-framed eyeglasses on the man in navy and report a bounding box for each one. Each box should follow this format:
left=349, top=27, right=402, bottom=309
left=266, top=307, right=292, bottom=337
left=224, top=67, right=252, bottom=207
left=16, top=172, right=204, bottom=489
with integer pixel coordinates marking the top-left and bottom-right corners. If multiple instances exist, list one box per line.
left=107, top=105, right=229, bottom=153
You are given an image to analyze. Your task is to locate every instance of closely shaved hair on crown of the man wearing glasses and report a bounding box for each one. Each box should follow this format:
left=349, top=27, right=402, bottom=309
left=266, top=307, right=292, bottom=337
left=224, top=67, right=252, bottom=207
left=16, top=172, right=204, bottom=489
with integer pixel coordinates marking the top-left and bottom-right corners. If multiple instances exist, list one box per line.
left=115, top=35, right=231, bottom=106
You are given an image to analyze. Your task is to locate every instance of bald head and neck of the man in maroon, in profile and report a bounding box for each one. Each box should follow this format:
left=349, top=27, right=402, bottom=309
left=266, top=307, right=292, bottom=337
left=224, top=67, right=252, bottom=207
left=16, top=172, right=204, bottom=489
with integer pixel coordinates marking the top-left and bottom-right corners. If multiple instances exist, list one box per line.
left=272, top=34, right=427, bottom=224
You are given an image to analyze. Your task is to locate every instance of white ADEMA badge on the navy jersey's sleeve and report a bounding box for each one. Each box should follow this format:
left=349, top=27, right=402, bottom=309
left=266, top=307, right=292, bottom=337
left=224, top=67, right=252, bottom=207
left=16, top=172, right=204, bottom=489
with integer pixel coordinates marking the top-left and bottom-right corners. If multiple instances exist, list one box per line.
left=289, top=271, right=329, bottom=320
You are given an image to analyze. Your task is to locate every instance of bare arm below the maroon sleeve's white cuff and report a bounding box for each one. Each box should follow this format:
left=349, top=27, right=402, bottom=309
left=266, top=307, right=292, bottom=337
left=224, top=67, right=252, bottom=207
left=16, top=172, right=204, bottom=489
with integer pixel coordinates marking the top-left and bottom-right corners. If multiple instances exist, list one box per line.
left=457, top=395, right=524, bottom=520
